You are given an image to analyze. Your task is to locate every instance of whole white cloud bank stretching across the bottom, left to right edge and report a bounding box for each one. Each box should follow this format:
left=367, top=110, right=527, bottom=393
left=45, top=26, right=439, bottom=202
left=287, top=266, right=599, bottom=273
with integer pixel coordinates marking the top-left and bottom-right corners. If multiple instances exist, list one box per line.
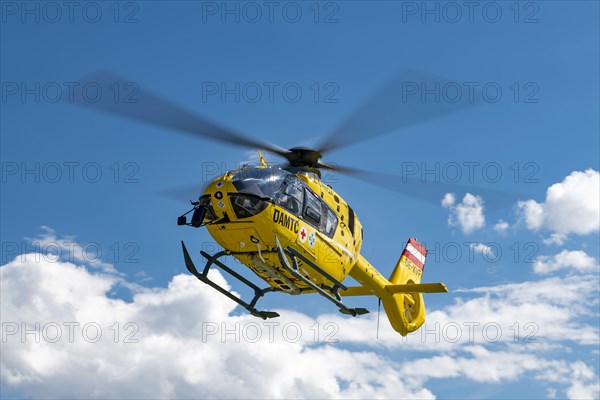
left=0, top=228, right=599, bottom=398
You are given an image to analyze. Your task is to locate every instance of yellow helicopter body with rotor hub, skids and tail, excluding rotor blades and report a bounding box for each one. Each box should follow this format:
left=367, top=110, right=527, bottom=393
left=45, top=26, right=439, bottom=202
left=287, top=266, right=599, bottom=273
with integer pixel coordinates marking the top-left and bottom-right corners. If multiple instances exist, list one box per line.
left=178, top=147, right=447, bottom=336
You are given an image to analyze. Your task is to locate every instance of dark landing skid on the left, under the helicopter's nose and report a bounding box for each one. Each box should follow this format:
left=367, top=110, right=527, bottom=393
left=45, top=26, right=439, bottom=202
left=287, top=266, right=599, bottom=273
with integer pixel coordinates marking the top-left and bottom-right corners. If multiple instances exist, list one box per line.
left=181, top=241, right=279, bottom=319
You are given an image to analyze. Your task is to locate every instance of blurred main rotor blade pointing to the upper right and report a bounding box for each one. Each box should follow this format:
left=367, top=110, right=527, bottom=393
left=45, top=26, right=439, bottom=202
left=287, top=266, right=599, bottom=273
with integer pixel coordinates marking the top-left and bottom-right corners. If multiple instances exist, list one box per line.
left=317, top=69, right=483, bottom=153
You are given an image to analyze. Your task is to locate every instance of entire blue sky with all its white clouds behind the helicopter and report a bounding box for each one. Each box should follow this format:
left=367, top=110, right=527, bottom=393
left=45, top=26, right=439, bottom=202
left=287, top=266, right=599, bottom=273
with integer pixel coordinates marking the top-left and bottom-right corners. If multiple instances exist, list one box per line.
left=0, top=1, right=600, bottom=398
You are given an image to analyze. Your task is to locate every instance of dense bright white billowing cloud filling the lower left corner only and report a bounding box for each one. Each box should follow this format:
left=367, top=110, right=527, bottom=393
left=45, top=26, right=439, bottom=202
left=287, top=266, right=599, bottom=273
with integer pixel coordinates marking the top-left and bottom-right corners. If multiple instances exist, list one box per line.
left=0, top=254, right=433, bottom=398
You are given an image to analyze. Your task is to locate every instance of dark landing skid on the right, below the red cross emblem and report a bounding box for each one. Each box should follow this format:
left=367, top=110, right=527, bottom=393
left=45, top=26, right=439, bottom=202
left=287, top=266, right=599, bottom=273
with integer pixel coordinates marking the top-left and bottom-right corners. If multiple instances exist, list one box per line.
left=275, top=237, right=369, bottom=317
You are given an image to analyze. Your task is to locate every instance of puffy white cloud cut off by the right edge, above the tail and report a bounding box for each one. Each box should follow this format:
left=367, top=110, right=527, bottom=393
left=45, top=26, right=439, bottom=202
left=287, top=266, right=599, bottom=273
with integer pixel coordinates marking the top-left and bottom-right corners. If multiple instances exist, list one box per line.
left=517, top=169, right=600, bottom=235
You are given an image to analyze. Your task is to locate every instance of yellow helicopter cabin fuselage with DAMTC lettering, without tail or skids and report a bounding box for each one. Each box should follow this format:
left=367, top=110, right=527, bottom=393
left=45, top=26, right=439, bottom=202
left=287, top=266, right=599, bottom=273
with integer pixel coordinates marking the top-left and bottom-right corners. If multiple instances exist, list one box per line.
left=200, top=167, right=362, bottom=294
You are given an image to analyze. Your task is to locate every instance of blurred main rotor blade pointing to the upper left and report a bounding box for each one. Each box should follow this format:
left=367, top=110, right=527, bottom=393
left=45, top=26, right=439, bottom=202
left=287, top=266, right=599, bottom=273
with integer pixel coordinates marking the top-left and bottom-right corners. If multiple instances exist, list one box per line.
left=73, top=72, right=288, bottom=156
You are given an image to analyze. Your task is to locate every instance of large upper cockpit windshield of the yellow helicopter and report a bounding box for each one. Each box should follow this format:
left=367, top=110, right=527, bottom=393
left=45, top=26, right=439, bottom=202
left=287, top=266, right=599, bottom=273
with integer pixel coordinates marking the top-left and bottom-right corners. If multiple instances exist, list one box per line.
left=231, top=168, right=292, bottom=199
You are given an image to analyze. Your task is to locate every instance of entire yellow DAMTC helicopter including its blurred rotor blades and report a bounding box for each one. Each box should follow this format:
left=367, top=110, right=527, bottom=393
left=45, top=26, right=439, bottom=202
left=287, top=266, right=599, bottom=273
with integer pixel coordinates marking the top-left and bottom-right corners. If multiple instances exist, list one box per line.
left=74, top=70, right=508, bottom=336
